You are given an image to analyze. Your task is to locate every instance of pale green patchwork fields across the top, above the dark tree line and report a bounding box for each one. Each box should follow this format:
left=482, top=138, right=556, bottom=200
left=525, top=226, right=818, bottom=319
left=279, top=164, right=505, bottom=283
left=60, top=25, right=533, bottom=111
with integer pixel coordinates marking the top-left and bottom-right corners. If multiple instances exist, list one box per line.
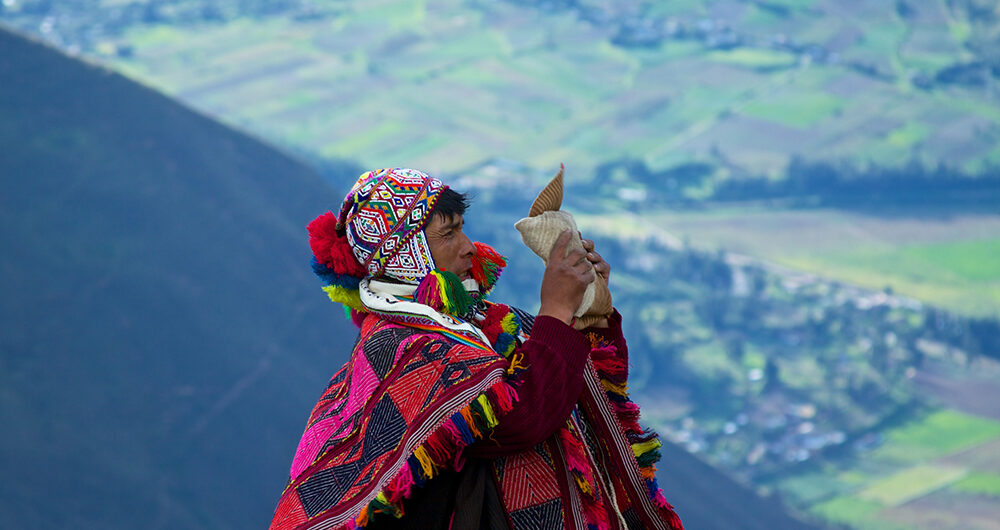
left=0, top=0, right=1000, bottom=176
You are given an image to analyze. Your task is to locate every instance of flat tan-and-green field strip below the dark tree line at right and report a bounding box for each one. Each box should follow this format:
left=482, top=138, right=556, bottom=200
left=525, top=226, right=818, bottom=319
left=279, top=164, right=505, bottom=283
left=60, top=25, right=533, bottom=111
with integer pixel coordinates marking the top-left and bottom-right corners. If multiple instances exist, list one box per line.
left=580, top=206, right=1000, bottom=317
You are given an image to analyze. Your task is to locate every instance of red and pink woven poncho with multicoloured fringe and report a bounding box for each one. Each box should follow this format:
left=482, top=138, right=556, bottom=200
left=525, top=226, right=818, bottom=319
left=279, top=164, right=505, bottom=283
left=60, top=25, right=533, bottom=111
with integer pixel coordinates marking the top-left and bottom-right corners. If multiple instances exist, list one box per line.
left=271, top=280, right=682, bottom=530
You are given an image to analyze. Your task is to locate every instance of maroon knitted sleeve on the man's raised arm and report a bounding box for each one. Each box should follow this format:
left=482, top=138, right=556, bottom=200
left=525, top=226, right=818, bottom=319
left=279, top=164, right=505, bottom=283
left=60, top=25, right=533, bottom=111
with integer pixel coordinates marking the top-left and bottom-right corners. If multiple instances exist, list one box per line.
left=465, top=316, right=588, bottom=458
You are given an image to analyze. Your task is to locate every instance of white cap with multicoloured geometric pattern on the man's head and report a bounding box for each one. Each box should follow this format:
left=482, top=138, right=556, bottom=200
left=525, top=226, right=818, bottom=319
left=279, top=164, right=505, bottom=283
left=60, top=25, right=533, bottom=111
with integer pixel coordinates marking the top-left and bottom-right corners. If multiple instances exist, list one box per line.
left=339, top=168, right=447, bottom=284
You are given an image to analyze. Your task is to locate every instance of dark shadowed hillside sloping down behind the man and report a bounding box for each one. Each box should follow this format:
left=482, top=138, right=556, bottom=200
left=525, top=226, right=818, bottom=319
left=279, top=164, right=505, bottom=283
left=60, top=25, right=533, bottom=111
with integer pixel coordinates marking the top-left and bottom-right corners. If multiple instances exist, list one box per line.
left=0, top=31, right=820, bottom=529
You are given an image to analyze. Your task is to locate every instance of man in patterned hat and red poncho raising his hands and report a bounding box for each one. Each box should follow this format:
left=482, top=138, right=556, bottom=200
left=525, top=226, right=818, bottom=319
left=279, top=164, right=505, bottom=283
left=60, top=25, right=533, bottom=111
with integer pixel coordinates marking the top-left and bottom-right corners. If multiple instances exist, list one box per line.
left=271, top=168, right=681, bottom=530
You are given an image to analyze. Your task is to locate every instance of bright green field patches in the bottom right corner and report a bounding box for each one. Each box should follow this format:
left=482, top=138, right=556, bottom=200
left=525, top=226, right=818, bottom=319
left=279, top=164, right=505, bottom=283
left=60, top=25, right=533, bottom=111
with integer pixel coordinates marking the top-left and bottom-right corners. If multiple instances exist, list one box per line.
left=776, top=402, right=1000, bottom=530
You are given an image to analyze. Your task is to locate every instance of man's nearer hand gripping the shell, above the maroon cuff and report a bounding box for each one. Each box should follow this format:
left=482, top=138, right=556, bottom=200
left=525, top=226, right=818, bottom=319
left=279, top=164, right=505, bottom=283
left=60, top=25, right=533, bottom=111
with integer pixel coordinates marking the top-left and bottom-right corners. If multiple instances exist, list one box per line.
left=538, top=230, right=592, bottom=325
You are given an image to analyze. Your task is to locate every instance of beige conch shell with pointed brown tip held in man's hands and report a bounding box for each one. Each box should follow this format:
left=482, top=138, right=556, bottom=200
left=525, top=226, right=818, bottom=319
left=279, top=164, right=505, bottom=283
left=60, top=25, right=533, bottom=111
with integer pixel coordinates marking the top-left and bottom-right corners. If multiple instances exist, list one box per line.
left=514, top=166, right=613, bottom=329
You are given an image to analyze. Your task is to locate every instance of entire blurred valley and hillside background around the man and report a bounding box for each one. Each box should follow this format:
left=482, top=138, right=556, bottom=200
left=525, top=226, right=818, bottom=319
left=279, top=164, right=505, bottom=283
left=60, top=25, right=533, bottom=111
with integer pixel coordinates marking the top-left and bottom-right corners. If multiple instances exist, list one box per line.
left=0, top=0, right=1000, bottom=530
